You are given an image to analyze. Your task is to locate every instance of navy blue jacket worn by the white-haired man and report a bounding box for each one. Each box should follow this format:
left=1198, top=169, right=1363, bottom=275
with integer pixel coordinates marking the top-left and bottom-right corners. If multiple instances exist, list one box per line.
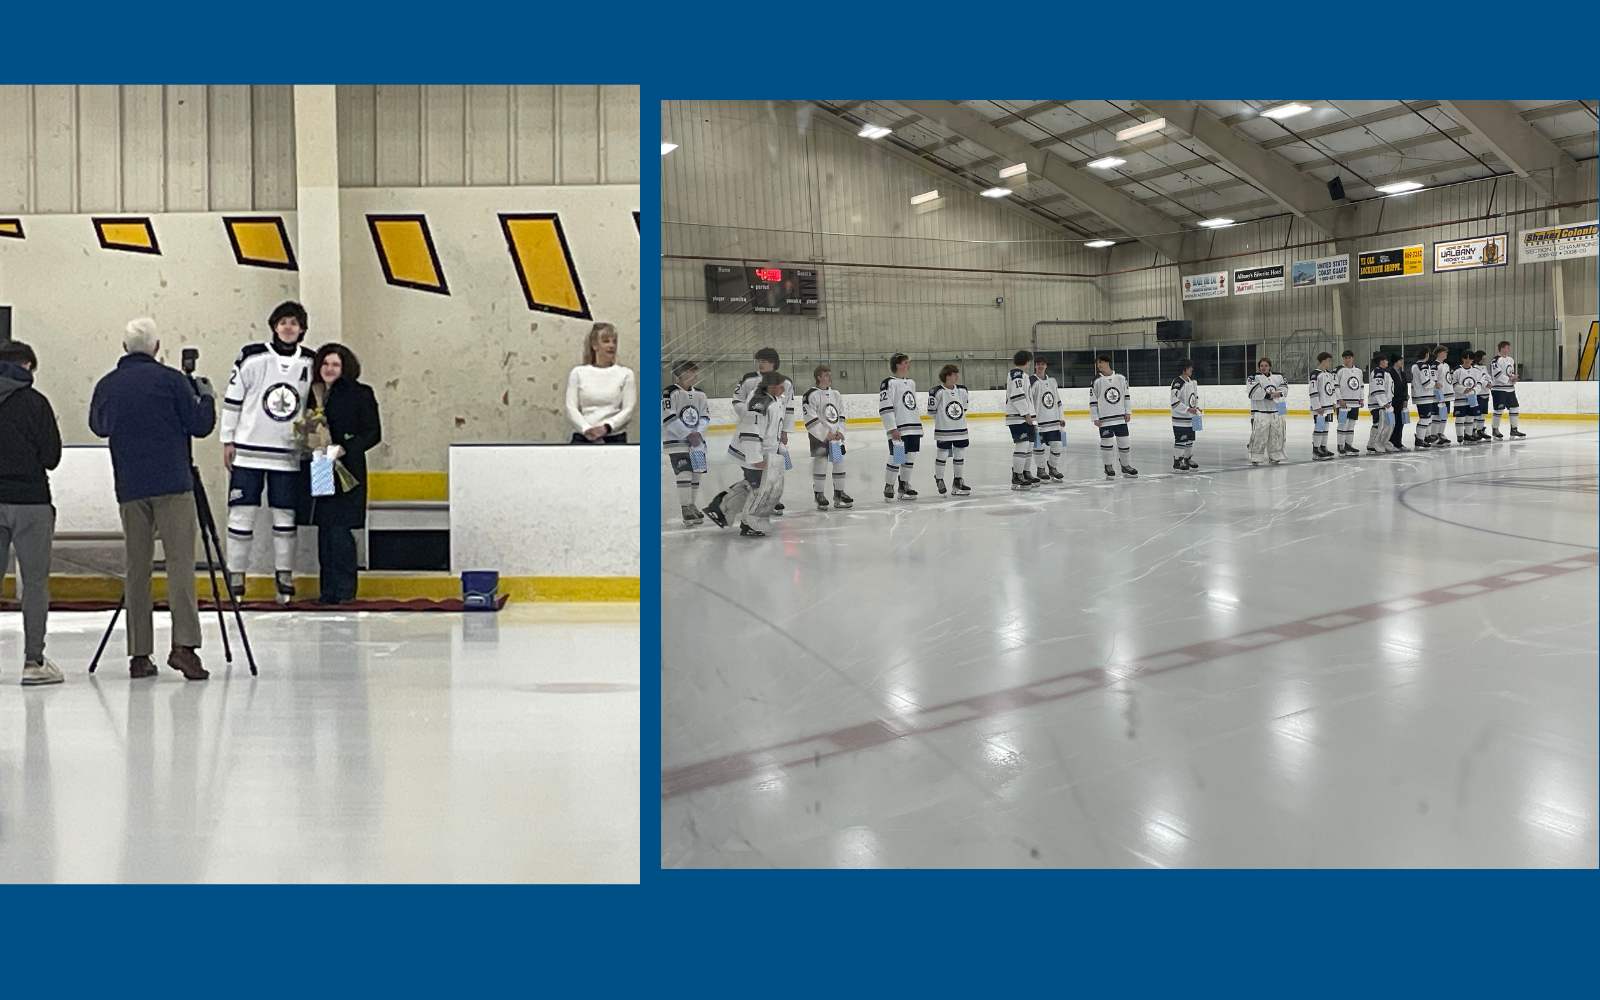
left=90, top=354, right=216, bottom=504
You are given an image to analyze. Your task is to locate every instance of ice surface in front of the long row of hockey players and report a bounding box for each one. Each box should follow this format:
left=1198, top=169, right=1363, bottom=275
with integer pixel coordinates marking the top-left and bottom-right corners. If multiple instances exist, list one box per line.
left=661, top=416, right=1600, bottom=867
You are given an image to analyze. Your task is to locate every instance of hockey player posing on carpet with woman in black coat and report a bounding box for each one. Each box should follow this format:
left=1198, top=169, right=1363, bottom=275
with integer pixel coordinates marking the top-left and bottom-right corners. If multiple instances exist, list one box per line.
left=221, top=302, right=317, bottom=603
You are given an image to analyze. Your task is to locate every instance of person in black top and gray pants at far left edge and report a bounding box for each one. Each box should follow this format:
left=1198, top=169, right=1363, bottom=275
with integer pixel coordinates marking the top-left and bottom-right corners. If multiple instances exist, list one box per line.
left=0, top=341, right=61, bottom=685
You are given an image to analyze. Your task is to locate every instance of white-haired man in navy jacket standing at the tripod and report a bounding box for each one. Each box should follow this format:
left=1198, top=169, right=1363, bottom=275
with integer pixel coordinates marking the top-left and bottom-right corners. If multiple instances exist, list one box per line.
left=90, top=317, right=216, bottom=680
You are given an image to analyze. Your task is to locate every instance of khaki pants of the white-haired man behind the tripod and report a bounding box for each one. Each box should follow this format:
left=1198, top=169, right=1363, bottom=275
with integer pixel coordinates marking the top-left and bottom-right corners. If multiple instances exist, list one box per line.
left=120, top=493, right=200, bottom=656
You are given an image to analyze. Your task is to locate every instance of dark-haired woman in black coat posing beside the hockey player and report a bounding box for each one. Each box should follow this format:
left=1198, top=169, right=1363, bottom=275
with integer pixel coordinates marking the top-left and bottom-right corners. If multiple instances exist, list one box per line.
left=299, top=344, right=384, bottom=605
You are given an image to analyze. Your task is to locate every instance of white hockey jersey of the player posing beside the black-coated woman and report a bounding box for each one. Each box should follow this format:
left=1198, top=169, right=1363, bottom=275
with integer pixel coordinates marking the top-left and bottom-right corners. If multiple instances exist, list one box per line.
left=221, top=344, right=317, bottom=472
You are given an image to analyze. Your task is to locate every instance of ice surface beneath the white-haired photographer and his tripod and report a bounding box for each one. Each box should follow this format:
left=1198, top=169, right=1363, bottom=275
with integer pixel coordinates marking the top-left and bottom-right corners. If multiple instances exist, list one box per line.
left=0, top=605, right=638, bottom=882
